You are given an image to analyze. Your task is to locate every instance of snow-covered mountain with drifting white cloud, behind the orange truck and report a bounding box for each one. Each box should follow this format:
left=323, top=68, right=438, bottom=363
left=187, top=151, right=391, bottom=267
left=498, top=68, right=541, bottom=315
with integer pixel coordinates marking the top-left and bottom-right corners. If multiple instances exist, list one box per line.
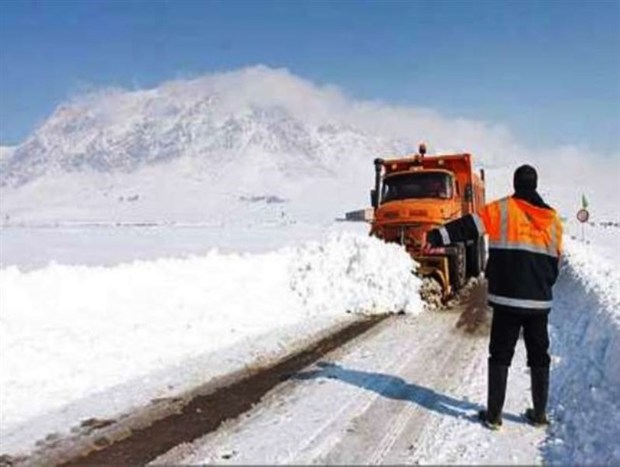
left=0, top=66, right=618, bottom=223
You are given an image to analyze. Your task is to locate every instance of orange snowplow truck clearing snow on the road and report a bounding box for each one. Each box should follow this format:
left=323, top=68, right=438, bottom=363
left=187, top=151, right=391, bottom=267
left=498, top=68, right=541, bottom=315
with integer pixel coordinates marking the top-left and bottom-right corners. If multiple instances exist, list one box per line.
left=370, top=144, right=486, bottom=298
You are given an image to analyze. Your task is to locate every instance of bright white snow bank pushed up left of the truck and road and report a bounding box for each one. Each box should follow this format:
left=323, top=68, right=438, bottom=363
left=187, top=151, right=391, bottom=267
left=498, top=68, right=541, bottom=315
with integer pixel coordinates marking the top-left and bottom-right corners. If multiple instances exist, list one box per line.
left=0, top=233, right=422, bottom=432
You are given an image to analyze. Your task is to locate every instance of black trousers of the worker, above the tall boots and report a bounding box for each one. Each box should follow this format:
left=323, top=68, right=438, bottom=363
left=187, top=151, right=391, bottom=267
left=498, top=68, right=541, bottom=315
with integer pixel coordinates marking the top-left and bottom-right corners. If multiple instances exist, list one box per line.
left=489, top=306, right=551, bottom=368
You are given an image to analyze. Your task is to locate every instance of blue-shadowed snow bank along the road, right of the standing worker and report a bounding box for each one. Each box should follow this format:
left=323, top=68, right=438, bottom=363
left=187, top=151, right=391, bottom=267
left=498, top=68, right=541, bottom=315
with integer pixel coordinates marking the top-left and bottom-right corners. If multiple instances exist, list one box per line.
left=543, top=236, right=620, bottom=465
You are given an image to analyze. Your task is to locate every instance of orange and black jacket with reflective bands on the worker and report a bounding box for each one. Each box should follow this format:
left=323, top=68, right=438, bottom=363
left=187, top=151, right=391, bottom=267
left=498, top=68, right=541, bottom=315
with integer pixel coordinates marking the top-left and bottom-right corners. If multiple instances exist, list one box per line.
left=427, top=190, right=562, bottom=313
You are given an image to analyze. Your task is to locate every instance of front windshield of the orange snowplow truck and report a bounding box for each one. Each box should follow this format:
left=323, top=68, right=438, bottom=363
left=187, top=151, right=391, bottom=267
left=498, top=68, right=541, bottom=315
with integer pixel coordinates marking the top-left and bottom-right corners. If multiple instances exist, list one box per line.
left=381, top=172, right=452, bottom=202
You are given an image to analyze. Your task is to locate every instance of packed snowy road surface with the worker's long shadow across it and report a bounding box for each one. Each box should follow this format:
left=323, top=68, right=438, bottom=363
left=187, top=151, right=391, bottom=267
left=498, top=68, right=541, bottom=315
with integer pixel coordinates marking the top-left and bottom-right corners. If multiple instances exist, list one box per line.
left=154, top=286, right=545, bottom=464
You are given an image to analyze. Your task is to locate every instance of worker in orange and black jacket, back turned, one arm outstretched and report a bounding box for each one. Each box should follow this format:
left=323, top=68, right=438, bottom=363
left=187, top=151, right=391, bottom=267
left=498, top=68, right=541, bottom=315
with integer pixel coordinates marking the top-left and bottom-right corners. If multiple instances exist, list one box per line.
left=427, top=165, right=562, bottom=429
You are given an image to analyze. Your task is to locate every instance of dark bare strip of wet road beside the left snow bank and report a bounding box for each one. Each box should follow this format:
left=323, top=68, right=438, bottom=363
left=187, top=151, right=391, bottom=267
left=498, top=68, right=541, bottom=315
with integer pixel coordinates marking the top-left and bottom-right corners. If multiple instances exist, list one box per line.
left=26, top=315, right=388, bottom=465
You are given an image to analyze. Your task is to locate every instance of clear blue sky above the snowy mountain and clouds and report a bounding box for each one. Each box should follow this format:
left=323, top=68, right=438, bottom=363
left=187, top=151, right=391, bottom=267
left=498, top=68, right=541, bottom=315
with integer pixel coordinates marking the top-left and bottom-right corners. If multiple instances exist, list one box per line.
left=0, top=0, right=620, bottom=153
